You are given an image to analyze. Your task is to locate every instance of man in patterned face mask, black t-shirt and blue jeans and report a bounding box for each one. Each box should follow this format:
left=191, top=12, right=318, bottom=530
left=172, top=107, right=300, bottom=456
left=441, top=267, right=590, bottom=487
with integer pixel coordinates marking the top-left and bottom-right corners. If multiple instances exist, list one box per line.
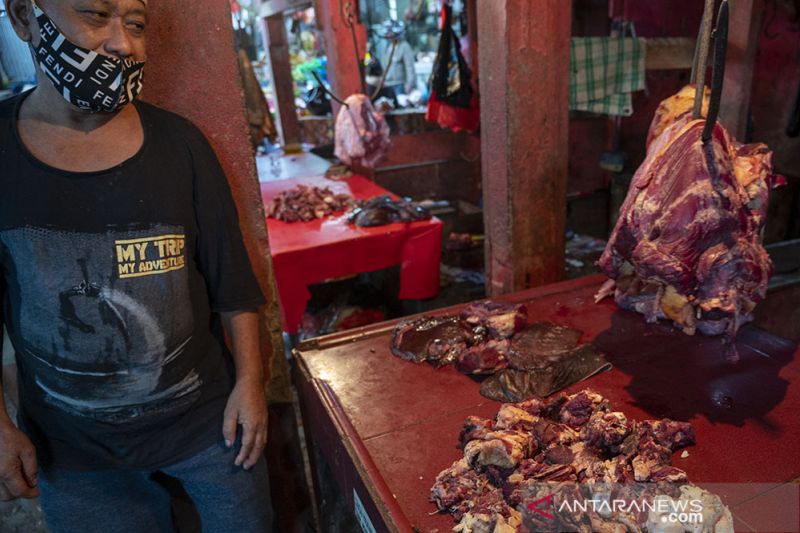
left=0, top=0, right=272, bottom=533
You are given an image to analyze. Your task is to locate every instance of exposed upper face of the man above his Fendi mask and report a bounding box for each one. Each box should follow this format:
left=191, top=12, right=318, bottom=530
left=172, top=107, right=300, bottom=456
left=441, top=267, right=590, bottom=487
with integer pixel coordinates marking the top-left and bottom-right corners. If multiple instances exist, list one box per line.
left=25, top=0, right=147, bottom=61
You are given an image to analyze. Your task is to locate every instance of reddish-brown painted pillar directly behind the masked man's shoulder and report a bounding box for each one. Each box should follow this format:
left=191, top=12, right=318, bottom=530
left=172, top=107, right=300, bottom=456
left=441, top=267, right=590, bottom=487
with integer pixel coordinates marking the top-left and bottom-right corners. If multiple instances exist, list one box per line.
left=144, top=0, right=283, bottom=382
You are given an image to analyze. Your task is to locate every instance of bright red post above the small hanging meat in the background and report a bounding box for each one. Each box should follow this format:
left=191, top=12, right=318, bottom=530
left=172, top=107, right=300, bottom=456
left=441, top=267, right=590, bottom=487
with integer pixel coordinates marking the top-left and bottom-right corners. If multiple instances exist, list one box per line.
left=314, top=0, right=367, bottom=107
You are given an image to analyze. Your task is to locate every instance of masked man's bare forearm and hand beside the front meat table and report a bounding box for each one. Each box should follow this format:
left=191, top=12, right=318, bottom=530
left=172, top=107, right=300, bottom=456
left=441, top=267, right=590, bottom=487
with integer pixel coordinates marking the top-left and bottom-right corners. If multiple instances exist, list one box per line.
left=220, top=311, right=267, bottom=469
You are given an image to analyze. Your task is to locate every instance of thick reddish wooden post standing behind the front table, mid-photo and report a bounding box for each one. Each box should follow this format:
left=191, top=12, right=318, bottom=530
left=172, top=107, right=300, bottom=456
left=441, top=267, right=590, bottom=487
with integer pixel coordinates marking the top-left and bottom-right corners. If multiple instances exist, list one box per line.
left=477, top=0, right=571, bottom=295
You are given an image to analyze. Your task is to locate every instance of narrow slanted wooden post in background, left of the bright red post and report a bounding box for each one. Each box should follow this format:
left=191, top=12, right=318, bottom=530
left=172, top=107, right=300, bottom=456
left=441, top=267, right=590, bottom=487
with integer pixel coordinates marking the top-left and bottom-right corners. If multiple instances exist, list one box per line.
left=263, top=13, right=300, bottom=146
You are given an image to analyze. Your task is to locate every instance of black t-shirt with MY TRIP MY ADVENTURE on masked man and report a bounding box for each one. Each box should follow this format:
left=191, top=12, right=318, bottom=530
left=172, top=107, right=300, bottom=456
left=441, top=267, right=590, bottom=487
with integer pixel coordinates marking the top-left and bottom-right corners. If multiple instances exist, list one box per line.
left=0, top=95, right=264, bottom=469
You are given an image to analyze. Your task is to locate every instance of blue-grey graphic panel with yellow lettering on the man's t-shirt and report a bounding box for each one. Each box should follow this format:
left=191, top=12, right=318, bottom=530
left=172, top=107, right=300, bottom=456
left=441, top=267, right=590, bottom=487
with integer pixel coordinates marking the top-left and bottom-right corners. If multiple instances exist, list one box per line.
left=0, top=225, right=201, bottom=422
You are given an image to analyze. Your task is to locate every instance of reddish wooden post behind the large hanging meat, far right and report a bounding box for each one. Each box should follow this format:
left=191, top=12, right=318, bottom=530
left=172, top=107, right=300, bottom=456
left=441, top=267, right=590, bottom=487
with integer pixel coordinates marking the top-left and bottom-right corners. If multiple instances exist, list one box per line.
left=719, top=0, right=764, bottom=142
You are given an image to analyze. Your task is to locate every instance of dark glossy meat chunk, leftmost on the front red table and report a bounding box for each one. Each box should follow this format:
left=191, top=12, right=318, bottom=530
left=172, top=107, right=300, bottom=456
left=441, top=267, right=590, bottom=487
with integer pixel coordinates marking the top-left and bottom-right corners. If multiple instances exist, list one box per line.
left=392, top=317, right=470, bottom=366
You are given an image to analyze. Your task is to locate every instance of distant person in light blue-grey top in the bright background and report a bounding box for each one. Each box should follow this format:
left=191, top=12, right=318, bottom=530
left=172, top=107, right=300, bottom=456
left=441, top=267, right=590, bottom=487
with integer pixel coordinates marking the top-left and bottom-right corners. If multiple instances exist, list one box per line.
left=375, top=20, right=417, bottom=95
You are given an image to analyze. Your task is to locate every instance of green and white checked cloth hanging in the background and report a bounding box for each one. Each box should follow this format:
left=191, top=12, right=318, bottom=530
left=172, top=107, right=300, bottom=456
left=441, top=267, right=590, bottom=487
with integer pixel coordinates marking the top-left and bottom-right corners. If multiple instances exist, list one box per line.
left=569, top=37, right=646, bottom=117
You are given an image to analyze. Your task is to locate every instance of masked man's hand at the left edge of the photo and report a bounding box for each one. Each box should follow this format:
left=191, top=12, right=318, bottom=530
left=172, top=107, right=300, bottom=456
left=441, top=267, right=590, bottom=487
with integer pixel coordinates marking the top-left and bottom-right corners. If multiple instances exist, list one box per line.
left=0, top=419, right=39, bottom=501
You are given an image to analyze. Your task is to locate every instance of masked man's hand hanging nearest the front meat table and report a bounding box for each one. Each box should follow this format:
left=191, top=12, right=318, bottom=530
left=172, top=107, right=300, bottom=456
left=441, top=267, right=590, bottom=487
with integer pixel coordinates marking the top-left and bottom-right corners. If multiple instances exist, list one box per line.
left=222, top=379, right=267, bottom=470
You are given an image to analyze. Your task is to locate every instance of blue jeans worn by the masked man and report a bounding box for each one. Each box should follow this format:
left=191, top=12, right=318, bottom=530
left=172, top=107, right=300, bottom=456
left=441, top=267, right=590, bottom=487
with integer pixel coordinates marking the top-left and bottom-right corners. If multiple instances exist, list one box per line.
left=39, top=442, right=275, bottom=533
